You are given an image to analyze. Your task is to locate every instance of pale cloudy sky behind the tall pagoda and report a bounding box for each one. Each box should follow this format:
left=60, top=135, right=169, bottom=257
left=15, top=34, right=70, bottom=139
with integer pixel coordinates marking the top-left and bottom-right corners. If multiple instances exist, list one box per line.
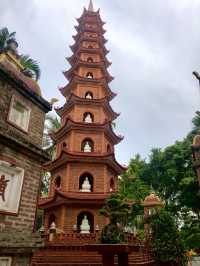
left=0, top=0, right=200, bottom=163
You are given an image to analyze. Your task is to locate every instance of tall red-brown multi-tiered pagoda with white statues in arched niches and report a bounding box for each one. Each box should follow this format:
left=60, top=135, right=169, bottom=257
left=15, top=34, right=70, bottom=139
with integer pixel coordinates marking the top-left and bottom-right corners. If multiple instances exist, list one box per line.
left=39, top=1, right=125, bottom=234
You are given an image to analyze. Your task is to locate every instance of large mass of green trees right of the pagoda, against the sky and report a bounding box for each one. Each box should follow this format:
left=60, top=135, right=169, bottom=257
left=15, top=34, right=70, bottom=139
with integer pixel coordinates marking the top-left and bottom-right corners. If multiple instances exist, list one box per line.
left=119, top=115, right=200, bottom=256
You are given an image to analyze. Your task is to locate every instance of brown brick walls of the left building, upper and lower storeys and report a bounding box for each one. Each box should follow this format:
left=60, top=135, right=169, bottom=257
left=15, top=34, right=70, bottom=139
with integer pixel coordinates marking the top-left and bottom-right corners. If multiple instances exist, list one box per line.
left=0, top=80, right=45, bottom=230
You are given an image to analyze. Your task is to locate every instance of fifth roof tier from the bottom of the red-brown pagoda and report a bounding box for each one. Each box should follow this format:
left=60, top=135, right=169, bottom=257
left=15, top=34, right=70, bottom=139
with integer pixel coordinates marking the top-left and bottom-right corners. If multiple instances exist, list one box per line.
left=60, top=76, right=116, bottom=100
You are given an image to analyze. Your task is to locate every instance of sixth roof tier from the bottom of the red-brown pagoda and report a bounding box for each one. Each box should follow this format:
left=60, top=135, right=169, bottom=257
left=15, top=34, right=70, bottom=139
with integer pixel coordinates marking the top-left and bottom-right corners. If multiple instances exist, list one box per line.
left=63, top=60, right=114, bottom=83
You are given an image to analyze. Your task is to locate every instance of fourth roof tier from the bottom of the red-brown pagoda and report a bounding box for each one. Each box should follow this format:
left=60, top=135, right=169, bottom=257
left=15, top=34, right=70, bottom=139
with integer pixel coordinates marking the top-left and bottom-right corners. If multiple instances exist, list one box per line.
left=55, top=93, right=120, bottom=121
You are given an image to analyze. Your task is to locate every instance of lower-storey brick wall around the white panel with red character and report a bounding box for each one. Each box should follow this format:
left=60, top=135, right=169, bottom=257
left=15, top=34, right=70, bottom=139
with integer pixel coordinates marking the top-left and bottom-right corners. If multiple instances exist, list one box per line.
left=0, top=144, right=42, bottom=230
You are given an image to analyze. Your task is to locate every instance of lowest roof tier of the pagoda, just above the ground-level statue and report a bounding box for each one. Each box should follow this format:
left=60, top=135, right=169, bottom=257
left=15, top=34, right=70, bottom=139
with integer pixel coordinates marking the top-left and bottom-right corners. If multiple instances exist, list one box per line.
left=38, top=189, right=110, bottom=209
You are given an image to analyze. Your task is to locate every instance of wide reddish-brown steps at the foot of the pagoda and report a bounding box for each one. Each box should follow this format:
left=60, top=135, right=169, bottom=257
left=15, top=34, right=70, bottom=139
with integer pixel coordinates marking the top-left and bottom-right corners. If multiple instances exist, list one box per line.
left=31, top=241, right=155, bottom=266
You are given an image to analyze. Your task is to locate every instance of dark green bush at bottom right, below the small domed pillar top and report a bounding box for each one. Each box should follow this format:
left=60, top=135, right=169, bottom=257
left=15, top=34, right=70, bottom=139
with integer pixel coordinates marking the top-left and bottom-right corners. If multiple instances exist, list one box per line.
left=150, top=209, right=187, bottom=266
